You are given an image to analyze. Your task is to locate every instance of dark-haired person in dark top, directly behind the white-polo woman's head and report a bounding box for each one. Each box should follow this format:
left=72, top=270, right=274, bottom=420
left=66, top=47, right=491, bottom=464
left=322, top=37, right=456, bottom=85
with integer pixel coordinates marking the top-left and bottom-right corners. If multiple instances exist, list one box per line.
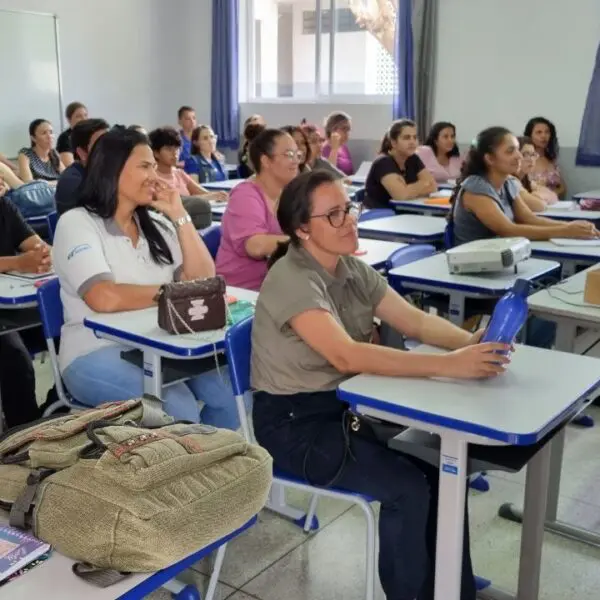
left=54, top=119, right=109, bottom=215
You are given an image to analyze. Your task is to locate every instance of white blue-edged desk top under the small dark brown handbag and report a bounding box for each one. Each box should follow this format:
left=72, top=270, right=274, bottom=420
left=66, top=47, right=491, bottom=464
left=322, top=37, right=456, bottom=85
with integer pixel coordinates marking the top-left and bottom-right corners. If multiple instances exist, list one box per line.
left=84, top=287, right=258, bottom=357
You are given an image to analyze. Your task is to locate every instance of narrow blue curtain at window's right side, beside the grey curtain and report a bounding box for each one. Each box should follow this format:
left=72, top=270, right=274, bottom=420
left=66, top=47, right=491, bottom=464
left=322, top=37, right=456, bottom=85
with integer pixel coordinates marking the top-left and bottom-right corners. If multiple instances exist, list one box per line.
left=392, top=0, right=416, bottom=119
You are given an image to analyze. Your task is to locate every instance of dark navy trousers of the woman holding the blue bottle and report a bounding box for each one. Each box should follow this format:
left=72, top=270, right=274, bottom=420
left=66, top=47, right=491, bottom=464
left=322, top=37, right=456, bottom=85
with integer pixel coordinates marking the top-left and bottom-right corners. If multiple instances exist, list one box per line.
left=253, top=391, right=476, bottom=600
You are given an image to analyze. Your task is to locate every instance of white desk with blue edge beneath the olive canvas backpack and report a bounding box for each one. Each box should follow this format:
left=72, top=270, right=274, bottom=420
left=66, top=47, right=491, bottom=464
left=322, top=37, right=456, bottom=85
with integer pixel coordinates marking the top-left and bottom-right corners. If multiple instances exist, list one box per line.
left=0, top=511, right=256, bottom=600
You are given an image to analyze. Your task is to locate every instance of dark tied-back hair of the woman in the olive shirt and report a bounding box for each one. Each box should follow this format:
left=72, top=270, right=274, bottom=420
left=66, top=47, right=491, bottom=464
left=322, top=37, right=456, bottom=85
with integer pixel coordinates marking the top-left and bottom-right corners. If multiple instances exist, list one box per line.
left=268, top=169, right=338, bottom=268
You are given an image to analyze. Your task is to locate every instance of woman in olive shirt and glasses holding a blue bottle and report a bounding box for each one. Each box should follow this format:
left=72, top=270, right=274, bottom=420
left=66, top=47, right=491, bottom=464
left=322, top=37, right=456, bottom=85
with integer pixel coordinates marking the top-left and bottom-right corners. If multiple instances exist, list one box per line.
left=252, top=171, right=509, bottom=600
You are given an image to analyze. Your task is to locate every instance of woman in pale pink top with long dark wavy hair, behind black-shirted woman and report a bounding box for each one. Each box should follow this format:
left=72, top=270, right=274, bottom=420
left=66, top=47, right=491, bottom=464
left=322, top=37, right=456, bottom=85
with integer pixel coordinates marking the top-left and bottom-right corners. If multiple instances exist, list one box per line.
left=417, top=121, right=463, bottom=183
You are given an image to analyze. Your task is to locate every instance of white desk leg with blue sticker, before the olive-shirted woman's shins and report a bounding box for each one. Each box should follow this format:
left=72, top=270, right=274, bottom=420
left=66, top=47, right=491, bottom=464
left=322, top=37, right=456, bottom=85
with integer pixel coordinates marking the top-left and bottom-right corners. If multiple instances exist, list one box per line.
left=435, top=432, right=467, bottom=600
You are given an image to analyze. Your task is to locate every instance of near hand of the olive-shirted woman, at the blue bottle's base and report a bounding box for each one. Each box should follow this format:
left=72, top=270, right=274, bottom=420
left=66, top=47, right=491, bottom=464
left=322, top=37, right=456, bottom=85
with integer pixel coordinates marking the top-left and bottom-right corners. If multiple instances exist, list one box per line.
left=440, top=343, right=511, bottom=379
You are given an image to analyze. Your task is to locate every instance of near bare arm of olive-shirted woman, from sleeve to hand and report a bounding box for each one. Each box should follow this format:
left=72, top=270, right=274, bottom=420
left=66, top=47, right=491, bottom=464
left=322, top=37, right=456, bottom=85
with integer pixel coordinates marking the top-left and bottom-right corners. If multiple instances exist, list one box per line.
left=289, top=309, right=509, bottom=379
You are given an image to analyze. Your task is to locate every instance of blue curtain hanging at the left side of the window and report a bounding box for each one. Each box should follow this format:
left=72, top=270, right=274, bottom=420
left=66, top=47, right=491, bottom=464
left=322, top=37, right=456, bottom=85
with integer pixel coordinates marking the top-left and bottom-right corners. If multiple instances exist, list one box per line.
left=211, top=0, right=240, bottom=148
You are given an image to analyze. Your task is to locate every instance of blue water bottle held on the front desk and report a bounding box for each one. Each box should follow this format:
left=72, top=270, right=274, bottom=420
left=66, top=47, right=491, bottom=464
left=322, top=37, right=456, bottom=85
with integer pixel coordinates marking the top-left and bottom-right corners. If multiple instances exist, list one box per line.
left=481, top=279, right=531, bottom=344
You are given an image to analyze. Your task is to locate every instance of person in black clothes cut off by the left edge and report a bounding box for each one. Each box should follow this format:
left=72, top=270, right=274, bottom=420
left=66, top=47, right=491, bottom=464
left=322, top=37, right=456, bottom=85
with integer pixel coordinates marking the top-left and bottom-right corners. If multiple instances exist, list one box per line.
left=0, top=179, right=52, bottom=428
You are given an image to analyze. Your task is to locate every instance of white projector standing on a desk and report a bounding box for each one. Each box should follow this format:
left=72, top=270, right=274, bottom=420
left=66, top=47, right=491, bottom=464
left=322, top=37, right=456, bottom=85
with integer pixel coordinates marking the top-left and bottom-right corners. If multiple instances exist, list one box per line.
left=446, top=238, right=531, bottom=274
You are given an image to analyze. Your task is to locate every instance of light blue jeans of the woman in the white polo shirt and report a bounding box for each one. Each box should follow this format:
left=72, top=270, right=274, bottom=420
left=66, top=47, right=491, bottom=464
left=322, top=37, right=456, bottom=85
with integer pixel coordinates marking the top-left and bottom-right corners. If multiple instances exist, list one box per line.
left=62, top=346, right=240, bottom=430
